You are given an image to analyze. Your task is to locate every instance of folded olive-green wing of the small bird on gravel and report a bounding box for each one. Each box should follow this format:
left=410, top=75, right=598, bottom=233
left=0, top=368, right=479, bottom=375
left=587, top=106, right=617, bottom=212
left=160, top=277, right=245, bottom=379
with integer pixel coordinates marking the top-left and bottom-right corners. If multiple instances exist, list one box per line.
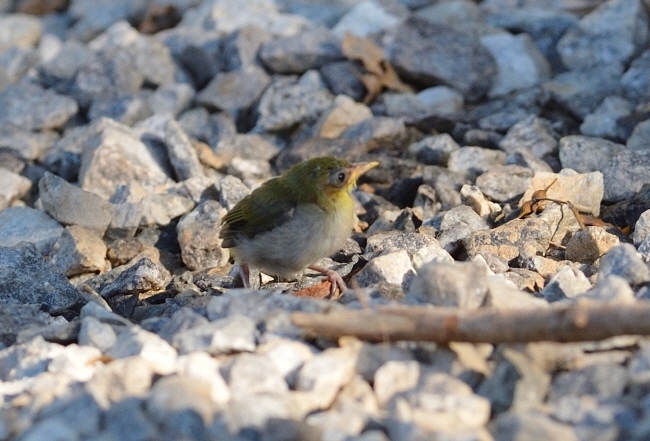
left=219, top=179, right=296, bottom=248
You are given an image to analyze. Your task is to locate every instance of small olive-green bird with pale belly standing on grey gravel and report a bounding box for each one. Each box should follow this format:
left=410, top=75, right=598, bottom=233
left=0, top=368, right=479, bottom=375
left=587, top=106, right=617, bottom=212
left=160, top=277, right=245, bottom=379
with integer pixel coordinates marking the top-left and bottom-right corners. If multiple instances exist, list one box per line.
left=219, top=156, right=379, bottom=298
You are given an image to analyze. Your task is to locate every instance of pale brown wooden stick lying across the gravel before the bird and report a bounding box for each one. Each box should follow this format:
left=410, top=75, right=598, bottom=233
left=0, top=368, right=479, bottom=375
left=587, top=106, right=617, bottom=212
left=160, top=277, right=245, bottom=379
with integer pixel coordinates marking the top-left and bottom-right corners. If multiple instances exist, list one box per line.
left=291, top=301, right=650, bottom=343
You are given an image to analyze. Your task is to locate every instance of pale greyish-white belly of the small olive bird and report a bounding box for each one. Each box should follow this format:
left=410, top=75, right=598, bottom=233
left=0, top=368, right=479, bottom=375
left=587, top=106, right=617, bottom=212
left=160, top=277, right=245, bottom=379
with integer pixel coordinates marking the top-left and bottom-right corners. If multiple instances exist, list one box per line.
left=232, top=204, right=354, bottom=277
